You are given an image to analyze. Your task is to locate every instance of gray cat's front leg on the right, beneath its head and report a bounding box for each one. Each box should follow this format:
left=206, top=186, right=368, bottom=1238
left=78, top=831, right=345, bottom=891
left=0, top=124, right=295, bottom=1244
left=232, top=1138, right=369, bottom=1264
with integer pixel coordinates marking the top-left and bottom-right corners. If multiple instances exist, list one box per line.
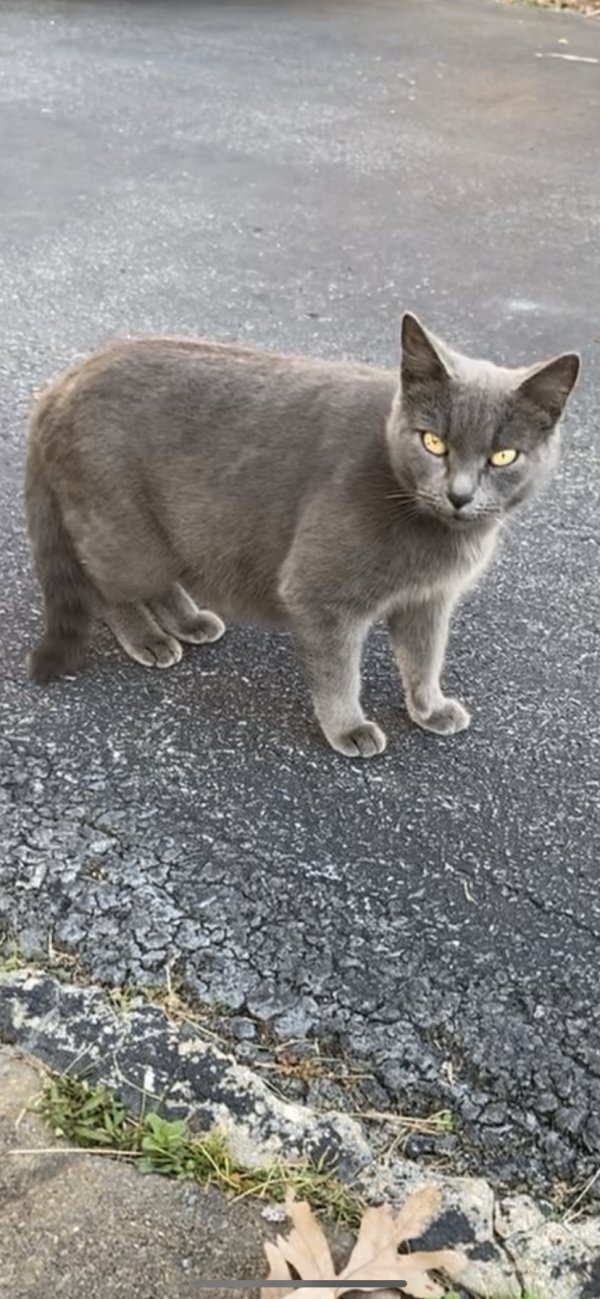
left=388, top=599, right=470, bottom=735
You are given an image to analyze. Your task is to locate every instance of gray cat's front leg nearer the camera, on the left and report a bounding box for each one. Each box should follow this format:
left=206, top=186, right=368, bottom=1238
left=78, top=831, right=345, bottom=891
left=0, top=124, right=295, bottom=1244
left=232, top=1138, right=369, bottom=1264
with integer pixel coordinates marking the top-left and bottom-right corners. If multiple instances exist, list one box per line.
left=288, top=608, right=387, bottom=757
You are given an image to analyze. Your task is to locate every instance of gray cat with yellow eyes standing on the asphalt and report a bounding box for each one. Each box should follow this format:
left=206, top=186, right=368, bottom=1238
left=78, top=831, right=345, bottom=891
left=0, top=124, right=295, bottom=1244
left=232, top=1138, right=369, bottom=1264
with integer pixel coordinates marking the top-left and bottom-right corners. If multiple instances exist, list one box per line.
left=26, top=314, right=579, bottom=757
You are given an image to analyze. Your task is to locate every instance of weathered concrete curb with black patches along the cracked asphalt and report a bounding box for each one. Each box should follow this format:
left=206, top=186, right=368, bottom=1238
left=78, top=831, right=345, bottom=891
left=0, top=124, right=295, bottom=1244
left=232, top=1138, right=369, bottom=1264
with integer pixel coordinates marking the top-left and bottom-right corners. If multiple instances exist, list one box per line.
left=0, top=970, right=600, bottom=1299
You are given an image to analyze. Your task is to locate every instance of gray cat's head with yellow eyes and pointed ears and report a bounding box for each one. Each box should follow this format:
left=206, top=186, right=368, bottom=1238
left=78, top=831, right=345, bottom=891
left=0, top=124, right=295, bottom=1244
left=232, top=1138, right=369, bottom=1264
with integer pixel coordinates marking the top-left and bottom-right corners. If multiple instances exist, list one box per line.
left=388, top=313, right=579, bottom=527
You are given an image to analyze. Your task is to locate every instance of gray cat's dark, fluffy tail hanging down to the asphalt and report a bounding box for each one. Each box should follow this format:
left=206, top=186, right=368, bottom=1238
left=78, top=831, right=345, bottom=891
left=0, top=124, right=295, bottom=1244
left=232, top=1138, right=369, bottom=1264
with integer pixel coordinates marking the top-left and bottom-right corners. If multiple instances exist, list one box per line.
left=25, top=428, right=92, bottom=686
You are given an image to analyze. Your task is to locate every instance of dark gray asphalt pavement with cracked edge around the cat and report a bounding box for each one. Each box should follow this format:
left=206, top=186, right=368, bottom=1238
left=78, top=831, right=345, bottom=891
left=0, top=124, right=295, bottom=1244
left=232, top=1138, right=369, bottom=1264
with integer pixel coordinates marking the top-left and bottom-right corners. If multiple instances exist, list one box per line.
left=0, top=0, right=600, bottom=1192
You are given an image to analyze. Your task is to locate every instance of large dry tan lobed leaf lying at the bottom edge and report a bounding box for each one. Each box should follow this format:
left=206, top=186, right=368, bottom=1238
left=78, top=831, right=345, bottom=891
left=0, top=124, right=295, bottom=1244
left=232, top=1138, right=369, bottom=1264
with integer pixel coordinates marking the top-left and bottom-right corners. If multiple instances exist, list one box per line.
left=261, top=1186, right=466, bottom=1299
